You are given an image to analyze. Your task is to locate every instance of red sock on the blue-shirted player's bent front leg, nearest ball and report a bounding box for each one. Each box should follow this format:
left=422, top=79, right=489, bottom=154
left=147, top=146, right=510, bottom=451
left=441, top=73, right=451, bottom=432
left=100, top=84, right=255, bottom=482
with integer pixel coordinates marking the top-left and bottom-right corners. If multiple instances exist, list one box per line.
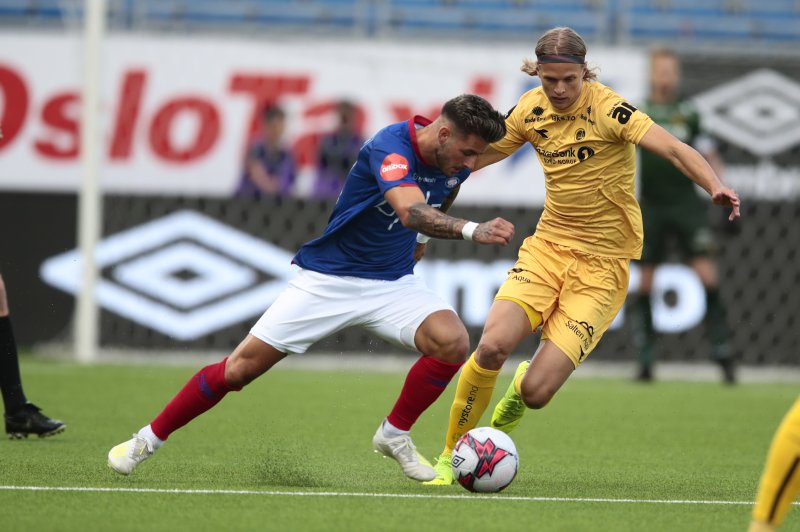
left=388, top=355, right=461, bottom=430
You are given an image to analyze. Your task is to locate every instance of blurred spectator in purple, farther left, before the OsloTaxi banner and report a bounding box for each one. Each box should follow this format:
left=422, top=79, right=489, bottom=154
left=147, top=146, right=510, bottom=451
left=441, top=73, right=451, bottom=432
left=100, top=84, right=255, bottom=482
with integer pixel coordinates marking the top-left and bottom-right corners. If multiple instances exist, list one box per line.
left=236, top=105, right=296, bottom=197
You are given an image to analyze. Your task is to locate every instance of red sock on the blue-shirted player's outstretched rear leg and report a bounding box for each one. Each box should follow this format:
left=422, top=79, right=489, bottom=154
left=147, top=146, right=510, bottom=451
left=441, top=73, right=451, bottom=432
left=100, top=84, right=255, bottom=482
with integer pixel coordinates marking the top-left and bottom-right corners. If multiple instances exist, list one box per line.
left=150, top=358, right=241, bottom=440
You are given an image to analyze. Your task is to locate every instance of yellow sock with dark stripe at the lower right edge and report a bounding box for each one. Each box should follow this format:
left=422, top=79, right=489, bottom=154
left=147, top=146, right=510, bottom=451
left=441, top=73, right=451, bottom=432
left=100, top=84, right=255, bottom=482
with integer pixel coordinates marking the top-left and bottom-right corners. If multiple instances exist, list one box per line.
left=751, top=399, right=800, bottom=530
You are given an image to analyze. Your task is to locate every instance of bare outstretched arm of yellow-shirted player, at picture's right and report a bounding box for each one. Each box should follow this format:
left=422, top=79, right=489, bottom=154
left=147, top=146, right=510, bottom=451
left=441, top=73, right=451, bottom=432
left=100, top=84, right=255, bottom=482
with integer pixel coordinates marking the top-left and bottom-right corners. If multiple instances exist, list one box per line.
left=639, top=124, right=740, bottom=220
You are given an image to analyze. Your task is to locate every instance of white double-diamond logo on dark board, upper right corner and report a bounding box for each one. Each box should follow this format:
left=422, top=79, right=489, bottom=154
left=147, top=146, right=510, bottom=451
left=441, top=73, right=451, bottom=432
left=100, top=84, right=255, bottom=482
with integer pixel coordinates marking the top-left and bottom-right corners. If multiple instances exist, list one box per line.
left=693, top=69, right=800, bottom=157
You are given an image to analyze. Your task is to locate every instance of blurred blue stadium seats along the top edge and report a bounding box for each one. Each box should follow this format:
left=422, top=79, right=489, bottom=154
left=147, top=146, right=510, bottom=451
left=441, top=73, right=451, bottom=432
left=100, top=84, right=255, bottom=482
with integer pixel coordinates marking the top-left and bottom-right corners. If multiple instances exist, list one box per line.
left=0, top=0, right=800, bottom=46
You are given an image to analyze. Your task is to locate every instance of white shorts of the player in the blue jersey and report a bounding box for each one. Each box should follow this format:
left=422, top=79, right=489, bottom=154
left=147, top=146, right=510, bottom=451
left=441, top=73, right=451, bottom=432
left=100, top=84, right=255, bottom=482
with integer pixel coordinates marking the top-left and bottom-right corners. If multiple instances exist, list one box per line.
left=250, top=269, right=455, bottom=353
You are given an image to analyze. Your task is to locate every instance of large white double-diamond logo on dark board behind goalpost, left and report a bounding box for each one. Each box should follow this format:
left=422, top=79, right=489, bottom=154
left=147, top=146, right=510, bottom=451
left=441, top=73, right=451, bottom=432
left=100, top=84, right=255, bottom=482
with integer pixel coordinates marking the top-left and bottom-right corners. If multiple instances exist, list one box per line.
left=40, top=211, right=294, bottom=340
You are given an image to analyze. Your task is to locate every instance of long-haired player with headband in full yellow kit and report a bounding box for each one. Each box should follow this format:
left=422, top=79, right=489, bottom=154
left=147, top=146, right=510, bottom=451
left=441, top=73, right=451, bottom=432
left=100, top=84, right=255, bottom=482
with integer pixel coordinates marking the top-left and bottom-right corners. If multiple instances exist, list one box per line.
left=422, top=28, right=739, bottom=484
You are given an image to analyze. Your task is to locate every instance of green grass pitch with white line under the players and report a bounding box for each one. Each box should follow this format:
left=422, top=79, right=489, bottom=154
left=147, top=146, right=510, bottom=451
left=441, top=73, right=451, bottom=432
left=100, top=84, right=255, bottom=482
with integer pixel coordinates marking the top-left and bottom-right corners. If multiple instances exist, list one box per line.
left=0, top=359, right=800, bottom=532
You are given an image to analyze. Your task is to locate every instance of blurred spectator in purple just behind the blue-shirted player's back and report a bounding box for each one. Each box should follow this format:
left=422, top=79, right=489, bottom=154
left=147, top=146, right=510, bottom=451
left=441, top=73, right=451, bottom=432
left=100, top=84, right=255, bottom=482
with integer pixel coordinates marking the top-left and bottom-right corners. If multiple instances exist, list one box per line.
left=311, top=100, right=364, bottom=198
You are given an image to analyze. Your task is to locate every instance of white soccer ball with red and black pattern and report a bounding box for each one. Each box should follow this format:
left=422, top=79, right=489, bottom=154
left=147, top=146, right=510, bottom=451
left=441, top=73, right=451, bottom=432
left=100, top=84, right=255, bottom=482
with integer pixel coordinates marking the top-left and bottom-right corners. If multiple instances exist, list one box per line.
left=451, top=427, right=519, bottom=492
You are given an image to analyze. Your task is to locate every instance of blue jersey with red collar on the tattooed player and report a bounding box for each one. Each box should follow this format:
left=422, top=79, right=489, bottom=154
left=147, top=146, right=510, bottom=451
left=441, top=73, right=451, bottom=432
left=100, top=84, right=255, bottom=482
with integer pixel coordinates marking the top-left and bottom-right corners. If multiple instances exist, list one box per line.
left=294, top=116, right=470, bottom=280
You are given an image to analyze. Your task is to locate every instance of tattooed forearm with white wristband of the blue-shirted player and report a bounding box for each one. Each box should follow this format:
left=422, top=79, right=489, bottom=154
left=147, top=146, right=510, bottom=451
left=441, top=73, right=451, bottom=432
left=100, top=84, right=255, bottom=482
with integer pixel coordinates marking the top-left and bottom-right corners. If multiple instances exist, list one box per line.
left=385, top=187, right=514, bottom=246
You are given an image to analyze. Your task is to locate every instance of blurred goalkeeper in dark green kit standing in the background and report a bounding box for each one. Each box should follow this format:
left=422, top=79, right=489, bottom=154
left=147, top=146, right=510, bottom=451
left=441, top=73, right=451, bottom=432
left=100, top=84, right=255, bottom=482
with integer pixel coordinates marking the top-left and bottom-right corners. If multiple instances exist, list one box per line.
left=635, top=49, right=736, bottom=384
